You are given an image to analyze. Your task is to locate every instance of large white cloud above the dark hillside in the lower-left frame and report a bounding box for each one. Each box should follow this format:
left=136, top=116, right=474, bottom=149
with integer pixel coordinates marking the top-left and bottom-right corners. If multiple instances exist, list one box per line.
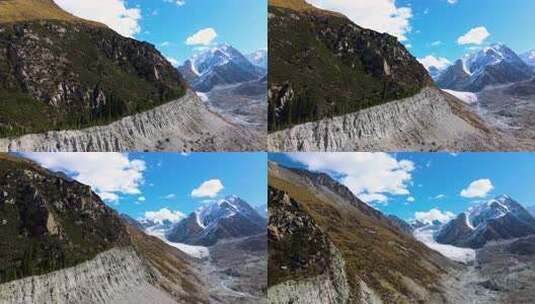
left=23, top=152, right=146, bottom=201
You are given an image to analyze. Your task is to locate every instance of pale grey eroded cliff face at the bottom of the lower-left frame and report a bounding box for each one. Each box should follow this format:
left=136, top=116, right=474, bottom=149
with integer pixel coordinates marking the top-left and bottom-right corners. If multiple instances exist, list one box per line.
left=0, top=248, right=176, bottom=304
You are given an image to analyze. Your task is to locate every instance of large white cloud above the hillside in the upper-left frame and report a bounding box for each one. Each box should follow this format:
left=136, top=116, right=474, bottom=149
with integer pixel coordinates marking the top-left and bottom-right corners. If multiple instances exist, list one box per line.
left=54, top=0, right=141, bottom=37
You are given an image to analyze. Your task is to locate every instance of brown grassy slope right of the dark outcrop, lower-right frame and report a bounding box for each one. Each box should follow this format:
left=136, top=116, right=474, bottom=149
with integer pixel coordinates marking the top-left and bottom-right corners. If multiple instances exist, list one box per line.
left=269, top=171, right=454, bottom=300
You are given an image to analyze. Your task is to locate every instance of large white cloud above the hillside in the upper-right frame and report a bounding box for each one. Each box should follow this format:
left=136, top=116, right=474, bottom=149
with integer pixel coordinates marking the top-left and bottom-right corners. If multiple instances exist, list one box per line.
left=308, top=0, right=412, bottom=41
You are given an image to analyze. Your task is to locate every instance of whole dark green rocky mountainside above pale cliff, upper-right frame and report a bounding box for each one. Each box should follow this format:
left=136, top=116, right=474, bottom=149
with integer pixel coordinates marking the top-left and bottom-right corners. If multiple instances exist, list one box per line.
left=268, top=0, right=433, bottom=131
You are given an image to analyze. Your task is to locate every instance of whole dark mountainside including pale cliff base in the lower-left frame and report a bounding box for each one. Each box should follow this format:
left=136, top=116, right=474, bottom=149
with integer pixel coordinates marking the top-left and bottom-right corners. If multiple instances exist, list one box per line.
left=0, top=154, right=218, bottom=304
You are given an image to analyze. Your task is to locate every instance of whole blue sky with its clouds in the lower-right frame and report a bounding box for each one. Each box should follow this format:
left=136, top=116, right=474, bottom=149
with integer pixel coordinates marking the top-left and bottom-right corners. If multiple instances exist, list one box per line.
left=269, top=153, right=535, bottom=220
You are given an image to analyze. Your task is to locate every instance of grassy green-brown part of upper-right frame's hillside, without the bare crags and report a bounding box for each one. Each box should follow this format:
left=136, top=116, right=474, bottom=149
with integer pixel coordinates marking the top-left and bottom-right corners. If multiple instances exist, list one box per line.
left=269, top=0, right=430, bottom=132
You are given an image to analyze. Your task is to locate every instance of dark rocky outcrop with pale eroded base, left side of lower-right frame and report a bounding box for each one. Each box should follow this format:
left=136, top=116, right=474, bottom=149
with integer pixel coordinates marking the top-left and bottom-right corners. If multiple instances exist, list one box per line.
left=268, top=187, right=350, bottom=304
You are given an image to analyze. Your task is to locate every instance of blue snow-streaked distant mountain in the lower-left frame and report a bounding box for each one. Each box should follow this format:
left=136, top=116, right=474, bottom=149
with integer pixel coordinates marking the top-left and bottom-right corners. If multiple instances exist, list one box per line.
left=167, top=196, right=266, bottom=246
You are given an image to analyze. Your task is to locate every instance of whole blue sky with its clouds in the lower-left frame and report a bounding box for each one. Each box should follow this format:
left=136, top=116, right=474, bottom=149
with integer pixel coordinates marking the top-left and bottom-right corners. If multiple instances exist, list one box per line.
left=24, top=153, right=267, bottom=218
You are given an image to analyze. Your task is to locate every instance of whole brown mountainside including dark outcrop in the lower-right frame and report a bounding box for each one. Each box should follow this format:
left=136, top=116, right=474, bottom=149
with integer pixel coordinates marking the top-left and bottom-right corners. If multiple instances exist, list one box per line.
left=268, top=164, right=462, bottom=303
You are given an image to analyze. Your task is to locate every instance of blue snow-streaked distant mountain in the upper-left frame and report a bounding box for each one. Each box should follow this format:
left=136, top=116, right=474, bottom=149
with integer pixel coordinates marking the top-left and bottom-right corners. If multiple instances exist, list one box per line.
left=178, top=44, right=267, bottom=93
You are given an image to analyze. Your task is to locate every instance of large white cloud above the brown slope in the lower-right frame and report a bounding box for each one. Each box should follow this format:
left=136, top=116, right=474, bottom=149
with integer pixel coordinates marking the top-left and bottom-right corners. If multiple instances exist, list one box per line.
left=287, top=153, right=415, bottom=203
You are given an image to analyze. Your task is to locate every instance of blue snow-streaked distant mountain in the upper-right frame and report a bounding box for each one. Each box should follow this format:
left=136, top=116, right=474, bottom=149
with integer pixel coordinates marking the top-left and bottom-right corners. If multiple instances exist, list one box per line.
left=438, top=43, right=535, bottom=92
